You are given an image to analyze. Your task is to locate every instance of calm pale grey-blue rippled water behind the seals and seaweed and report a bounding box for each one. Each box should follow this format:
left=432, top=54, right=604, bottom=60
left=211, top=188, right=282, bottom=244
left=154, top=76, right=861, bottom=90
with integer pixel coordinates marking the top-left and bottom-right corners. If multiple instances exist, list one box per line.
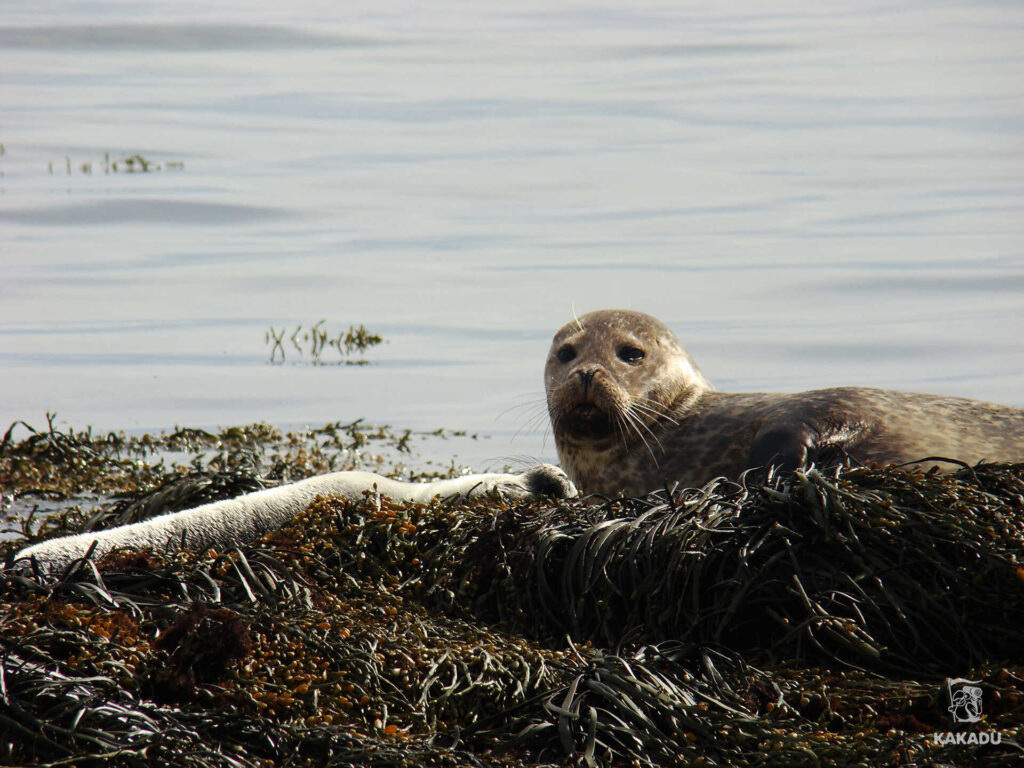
left=0, top=0, right=1024, bottom=468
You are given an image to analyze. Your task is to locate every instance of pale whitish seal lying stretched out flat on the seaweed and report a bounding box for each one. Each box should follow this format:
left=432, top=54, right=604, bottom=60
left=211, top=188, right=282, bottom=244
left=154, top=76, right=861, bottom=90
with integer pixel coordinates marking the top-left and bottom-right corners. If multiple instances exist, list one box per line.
left=14, top=464, right=577, bottom=574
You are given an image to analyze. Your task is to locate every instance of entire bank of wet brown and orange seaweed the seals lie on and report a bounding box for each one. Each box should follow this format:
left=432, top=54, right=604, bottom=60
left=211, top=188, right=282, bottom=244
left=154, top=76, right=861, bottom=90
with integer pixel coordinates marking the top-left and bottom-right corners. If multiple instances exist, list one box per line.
left=0, top=423, right=1024, bottom=766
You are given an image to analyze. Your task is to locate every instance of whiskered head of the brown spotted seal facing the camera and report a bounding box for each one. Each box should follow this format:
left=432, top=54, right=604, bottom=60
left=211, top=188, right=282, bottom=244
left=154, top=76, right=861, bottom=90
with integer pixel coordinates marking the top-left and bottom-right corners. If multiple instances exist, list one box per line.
left=544, top=309, right=712, bottom=477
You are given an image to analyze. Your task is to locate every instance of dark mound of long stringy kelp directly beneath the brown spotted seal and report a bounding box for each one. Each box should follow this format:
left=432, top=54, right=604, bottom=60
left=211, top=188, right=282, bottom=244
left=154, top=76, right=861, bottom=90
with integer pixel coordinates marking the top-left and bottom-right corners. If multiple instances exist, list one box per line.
left=468, top=467, right=1024, bottom=674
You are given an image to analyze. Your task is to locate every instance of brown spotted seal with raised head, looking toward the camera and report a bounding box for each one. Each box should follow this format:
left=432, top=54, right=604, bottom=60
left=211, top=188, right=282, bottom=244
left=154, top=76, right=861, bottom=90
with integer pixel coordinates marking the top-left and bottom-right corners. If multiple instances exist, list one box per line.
left=544, top=309, right=1024, bottom=496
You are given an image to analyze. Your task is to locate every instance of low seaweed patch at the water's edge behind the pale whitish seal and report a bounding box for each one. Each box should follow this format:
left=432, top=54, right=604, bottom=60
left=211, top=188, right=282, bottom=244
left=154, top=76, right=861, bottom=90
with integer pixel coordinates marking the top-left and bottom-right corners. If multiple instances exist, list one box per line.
left=0, top=414, right=465, bottom=538
